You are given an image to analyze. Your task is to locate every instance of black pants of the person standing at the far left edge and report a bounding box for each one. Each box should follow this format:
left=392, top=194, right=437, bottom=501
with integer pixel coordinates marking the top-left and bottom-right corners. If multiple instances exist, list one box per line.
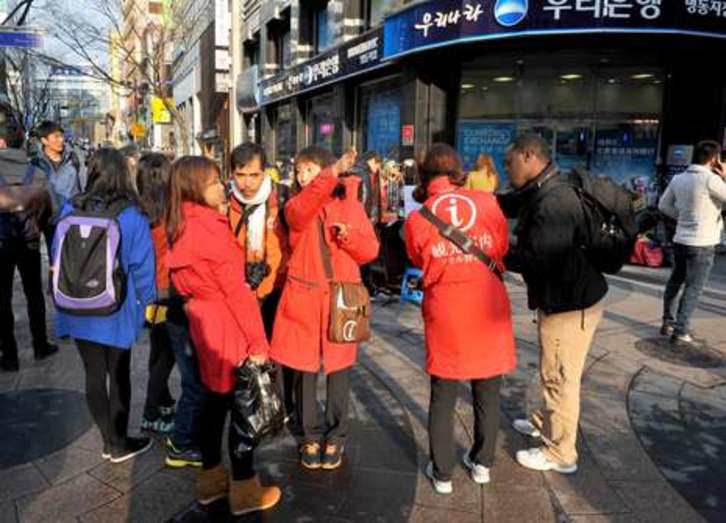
left=0, top=241, right=48, bottom=362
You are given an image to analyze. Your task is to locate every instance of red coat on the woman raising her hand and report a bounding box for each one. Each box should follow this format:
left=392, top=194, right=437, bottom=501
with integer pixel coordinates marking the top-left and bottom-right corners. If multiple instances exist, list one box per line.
left=270, top=170, right=378, bottom=373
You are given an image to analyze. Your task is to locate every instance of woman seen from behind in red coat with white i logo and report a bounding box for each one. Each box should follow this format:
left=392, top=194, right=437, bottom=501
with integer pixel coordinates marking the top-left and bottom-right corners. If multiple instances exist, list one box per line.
left=405, top=144, right=516, bottom=494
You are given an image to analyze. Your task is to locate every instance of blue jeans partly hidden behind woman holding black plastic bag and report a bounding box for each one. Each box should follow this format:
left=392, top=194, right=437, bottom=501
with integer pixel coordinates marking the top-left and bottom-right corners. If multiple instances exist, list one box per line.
left=166, top=321, right=206, bottom=450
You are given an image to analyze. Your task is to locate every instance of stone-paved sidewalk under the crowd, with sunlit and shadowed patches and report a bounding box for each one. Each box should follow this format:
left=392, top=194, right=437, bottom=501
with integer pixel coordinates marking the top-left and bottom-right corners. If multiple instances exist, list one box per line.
left=0, top=258, right=726, bottom=523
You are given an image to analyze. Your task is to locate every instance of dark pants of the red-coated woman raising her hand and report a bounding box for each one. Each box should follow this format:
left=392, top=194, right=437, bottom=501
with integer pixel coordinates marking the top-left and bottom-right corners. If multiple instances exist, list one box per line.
left=295, top=369, right=350, bottom=445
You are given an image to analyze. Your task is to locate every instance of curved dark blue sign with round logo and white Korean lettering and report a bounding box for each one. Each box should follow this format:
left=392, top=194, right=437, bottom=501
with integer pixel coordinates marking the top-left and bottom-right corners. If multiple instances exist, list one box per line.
left=383, top=0, right=726, bottom=59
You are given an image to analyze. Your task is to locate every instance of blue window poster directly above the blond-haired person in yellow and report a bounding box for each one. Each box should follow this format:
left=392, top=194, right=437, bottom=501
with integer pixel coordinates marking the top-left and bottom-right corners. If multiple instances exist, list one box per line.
left=456, top=120, right=517, bottom=178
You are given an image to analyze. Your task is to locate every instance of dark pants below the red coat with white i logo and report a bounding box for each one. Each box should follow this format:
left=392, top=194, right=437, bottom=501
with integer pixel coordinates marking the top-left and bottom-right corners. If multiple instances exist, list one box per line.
left=429, top=376, right=502, bottom=481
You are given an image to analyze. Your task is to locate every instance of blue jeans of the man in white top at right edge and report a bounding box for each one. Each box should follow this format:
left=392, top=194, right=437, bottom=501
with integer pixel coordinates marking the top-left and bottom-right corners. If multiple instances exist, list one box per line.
left=663, top=243, right=716, bottom=334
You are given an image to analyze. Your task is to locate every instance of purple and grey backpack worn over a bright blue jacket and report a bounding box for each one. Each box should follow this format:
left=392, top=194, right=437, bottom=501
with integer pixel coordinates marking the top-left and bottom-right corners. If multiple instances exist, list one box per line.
left=50, top=200, right=131, bottom=316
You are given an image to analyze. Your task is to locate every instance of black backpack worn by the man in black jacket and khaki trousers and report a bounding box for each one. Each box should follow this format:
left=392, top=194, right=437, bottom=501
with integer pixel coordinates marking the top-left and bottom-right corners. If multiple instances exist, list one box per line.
left=569, top=170, right=638, bottom=274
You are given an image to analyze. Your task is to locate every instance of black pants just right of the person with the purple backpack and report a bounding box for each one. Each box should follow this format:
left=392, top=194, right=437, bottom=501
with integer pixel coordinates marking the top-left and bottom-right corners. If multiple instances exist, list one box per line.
left=144, top=323, right=175, bottom=421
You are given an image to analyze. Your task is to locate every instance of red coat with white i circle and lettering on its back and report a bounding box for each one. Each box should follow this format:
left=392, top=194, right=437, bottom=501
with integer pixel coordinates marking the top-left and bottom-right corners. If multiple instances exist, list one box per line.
left=405, top=177, right=516, bottom=380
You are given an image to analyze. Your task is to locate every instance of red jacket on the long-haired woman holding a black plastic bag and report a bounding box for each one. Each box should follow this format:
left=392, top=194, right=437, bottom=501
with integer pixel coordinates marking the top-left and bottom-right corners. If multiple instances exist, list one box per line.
left=167, top=202, right=268, bottom=394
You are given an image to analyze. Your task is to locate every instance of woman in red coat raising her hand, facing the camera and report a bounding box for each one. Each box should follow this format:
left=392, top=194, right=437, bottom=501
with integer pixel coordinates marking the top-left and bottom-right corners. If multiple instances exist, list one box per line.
left=270, top=147, right=378, bottom=470
